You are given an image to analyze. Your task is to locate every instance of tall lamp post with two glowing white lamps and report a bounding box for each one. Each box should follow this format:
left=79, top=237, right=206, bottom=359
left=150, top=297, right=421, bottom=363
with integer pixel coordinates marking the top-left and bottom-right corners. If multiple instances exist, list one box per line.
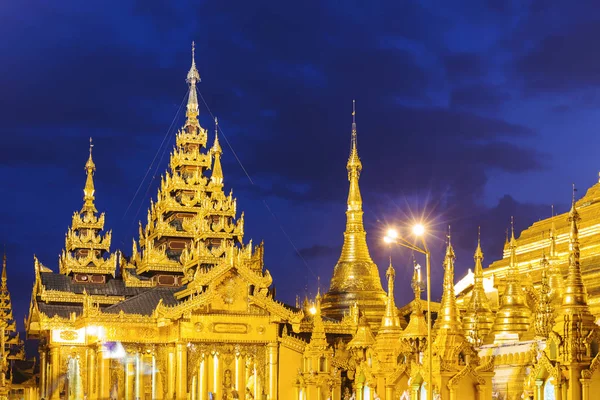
left=383, top=224, right=433, bottom=400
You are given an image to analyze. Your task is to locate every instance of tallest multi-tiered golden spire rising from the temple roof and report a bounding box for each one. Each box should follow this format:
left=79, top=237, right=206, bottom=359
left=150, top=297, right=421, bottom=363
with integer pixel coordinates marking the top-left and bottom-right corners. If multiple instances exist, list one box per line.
left=131, top=46, right=251, bottom=286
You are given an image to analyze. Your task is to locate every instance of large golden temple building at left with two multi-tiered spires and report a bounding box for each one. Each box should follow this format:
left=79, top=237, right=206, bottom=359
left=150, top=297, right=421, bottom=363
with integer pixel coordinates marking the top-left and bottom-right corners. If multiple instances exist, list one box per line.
left=26, top=43, right=308, bottom=400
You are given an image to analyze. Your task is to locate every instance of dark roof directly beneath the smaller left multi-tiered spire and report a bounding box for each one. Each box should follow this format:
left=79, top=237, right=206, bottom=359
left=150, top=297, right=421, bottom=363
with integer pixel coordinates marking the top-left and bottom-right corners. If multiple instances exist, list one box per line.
left=40, top=272, right=148, bottom=297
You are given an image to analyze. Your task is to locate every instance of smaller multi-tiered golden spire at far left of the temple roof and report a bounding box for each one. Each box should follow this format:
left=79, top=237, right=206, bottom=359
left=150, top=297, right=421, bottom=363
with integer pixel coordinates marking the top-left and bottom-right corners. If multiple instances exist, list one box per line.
left=58, top=138, right=117, bottom=283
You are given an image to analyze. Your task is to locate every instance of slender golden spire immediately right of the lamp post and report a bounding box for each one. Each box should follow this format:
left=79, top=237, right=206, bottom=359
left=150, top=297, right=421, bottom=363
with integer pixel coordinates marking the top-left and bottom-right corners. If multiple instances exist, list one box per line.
left=434, top=227, right=463, bottom=334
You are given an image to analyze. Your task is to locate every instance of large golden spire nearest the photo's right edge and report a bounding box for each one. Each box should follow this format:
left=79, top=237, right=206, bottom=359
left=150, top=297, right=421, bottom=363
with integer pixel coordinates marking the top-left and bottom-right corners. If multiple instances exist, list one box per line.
left=553, top=185, right=598, bottom=362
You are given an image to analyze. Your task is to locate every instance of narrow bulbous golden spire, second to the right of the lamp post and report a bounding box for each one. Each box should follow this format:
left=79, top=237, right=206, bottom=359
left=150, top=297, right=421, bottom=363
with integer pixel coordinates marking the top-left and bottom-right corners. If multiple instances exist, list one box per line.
left=463, top=228, right=494, bottom=345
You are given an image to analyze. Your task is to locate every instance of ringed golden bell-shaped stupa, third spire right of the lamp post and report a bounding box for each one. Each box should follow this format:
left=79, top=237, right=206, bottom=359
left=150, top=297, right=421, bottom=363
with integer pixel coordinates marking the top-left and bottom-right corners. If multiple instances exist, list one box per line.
left=494, top=217, right=531, bottom=339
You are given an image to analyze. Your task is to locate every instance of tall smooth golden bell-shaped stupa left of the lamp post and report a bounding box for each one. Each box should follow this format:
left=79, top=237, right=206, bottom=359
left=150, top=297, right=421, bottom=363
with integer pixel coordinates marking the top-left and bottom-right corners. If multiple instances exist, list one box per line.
left=323, top=102, right=386, bottom=328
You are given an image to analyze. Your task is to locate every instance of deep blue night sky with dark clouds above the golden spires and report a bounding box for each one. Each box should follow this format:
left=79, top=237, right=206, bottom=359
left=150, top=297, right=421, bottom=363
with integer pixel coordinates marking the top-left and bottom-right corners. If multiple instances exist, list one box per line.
left=0, top=0, right=600, bottom=329
